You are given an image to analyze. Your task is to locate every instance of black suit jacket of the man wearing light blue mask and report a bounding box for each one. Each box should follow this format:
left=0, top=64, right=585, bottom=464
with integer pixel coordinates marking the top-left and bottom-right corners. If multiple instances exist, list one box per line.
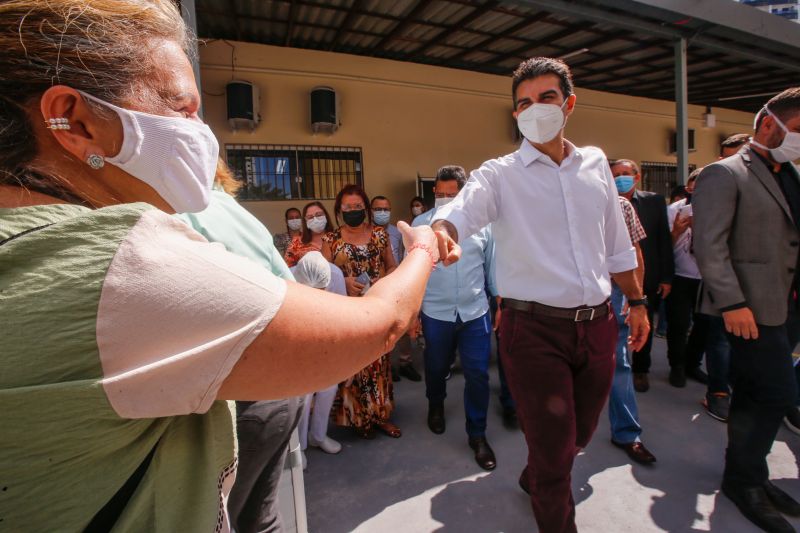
left=631, top=190, right=675, bottom=296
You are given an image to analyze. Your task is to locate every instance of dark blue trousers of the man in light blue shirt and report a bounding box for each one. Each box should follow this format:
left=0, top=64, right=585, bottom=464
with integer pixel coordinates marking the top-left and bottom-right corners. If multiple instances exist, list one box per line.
left=420, top=313, right=492, bottom=437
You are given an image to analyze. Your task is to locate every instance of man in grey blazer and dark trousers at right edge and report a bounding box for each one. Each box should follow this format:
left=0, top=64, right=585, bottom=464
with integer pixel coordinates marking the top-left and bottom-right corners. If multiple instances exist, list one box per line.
left=693, top=87, right=800, bottom=532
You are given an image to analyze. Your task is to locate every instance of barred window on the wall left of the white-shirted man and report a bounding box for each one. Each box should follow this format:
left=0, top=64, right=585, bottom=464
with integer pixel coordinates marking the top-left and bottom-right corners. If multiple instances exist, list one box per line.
left=225, top=144, right=364, bottom=200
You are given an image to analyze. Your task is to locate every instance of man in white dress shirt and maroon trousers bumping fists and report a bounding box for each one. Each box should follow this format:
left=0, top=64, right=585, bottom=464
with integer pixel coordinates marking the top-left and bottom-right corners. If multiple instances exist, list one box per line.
left=433, top=58, right=649, bottom=533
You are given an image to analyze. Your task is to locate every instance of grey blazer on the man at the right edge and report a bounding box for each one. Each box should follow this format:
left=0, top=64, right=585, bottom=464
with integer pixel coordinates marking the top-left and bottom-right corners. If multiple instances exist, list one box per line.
left=692, top=146, right=800, bottom=326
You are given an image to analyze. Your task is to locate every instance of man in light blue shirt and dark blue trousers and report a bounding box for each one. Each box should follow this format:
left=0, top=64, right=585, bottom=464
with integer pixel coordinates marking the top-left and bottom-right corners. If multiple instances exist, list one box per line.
left=412, top=166, right=497, bottom=470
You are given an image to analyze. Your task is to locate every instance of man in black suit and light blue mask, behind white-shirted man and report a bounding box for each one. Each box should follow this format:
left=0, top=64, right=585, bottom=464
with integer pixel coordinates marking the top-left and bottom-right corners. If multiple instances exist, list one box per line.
left=611, top=159, right=675, bottom=392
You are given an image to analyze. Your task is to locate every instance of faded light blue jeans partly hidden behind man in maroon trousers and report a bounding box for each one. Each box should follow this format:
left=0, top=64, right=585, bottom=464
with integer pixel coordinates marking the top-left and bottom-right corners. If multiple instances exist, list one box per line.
left=608, top=285, right=642, bottom=444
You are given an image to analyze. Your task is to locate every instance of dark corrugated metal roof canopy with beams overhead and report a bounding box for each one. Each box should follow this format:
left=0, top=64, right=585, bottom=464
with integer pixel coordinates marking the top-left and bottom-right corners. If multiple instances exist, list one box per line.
left=195, top=0, right=800, bottom=111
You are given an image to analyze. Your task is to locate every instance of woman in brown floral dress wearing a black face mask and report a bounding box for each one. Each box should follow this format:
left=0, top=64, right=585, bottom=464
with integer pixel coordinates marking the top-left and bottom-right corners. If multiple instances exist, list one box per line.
left=322, top=185, right=401, bottom=439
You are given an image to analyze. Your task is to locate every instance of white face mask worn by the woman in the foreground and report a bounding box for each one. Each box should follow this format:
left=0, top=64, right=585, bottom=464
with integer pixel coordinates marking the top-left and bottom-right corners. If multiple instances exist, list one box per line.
left=80, top=91, right=219, bottom=213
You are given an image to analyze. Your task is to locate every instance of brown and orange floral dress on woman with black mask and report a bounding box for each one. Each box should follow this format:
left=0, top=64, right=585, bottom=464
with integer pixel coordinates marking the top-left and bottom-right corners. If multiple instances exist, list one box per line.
left=322, top=226, right=394, bottom=430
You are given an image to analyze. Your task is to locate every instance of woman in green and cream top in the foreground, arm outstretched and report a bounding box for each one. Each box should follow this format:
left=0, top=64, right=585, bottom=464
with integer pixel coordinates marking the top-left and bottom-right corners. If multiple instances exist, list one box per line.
left=0, top=0, right=438, bottom=531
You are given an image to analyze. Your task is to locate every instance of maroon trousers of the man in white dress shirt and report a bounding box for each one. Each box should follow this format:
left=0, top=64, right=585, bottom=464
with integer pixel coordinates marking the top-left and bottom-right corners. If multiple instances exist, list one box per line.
left=500, top=307, right=617, bottom=533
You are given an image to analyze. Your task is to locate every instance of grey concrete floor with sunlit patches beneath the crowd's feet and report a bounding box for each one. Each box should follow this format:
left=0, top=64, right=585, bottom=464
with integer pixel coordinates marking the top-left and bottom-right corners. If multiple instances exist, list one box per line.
left=305, top=339, right=800, bottom=533
